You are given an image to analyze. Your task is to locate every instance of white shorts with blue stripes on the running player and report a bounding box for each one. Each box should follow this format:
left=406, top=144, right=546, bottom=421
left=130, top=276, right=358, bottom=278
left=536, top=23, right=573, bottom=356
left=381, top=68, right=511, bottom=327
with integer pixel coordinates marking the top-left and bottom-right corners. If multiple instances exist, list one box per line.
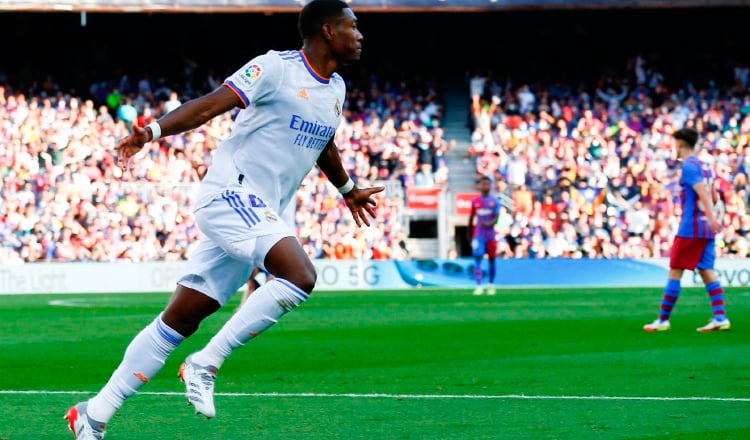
left=177, top=184, right=294, bottom=306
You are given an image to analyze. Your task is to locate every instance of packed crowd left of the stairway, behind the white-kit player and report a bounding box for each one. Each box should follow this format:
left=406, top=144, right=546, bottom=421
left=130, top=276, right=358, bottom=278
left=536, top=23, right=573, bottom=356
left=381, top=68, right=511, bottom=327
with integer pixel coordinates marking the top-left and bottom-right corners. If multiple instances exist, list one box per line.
left=0, top=68, right=451, bottom=264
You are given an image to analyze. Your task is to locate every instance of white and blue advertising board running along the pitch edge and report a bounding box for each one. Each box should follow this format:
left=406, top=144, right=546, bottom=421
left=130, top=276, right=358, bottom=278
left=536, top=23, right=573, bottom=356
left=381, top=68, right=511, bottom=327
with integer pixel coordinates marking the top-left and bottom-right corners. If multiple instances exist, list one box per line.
left=0, top=258, right=750, bottom=294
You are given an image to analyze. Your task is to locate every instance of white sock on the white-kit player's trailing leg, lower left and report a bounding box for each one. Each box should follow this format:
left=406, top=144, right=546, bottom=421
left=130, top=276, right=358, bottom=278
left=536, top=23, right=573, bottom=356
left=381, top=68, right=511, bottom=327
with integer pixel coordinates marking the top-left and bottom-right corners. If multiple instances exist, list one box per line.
left=87, top=315, right=185, bottom=423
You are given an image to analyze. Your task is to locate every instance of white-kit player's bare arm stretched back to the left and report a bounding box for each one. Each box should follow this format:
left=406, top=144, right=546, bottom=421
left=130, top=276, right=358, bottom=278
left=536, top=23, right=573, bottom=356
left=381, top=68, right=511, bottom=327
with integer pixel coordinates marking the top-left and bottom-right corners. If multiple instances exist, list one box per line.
left=115, top=86, right=245, bottom=167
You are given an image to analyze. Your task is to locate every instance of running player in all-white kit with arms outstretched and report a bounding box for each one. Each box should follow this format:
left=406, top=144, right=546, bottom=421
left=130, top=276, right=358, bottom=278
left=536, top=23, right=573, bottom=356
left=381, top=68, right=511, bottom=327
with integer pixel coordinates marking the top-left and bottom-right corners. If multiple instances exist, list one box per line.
left=65, top=0, right=383, bottom=440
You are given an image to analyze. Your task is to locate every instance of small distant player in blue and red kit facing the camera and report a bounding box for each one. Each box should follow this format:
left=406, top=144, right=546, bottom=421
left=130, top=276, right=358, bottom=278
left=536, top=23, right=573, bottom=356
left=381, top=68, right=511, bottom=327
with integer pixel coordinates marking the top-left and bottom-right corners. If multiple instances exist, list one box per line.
left=468, top=176, right=500, bottom=295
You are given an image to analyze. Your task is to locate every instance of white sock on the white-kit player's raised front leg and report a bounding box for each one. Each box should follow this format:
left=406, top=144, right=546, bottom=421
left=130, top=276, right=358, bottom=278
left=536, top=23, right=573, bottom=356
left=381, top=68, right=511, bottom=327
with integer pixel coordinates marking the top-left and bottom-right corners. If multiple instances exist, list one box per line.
left=192, top=278, right=307, bottom=368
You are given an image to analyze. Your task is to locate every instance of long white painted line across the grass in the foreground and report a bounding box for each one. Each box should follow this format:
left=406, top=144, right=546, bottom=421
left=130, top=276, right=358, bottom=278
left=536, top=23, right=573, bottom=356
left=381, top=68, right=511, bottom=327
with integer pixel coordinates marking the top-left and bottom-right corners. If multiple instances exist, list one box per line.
left=0, top=390, right=750, bottom=402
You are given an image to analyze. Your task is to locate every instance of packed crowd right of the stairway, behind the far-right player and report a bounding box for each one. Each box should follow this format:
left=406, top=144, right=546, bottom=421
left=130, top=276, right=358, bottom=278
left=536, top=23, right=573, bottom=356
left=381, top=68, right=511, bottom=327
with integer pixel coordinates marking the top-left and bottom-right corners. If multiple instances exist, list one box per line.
left=467, top=56, right=750, bottom=258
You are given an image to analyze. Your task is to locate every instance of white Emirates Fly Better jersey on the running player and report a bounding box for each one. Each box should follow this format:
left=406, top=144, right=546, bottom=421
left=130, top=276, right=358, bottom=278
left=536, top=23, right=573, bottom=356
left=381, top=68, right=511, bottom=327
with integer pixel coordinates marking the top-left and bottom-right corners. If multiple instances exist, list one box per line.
left=197, top=50, right=346, bottom=213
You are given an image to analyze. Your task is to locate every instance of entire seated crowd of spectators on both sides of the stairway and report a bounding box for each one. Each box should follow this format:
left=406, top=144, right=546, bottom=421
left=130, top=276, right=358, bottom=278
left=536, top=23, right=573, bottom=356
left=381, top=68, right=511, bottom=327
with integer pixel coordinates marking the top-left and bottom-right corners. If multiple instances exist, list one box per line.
left=0, top=54, right=750, bottom=264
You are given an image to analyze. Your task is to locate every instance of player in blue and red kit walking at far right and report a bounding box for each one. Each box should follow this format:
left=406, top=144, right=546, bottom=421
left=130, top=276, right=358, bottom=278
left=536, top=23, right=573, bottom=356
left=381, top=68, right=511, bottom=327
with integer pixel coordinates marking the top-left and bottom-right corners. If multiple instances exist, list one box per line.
left=643, top=128, right=731, bottom=332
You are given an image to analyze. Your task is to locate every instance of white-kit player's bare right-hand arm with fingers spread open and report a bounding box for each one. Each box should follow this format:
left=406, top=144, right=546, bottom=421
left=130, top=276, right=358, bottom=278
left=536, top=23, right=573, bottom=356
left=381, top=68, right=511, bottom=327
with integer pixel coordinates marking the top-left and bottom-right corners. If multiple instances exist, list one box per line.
left=317, top=139, right=385, bottom=227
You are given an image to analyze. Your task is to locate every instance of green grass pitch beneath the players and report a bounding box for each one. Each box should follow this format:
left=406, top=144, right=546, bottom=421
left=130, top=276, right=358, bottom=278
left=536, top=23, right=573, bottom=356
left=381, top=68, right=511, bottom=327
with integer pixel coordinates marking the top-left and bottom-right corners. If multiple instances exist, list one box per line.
left=0, top=288, right=750, bottom=440
